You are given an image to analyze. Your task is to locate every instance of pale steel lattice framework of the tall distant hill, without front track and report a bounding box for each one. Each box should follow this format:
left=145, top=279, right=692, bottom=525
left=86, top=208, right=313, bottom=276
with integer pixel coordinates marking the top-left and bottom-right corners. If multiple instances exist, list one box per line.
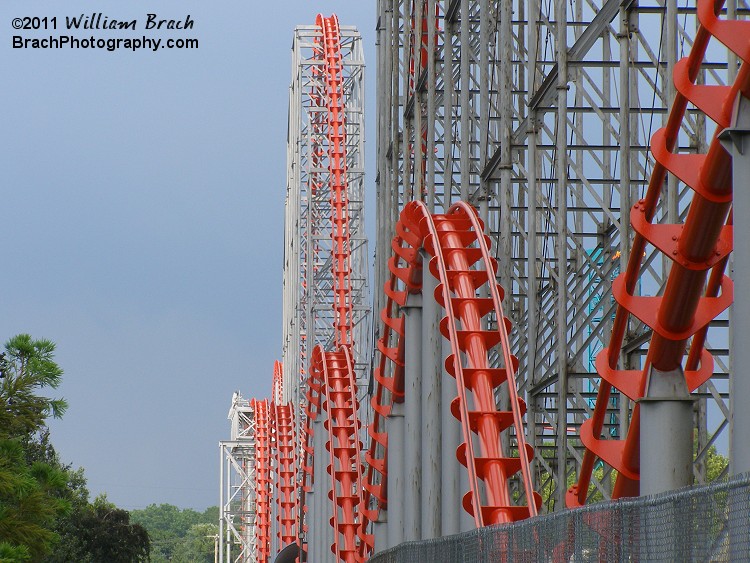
left=282, top=18, right=371, bottom=410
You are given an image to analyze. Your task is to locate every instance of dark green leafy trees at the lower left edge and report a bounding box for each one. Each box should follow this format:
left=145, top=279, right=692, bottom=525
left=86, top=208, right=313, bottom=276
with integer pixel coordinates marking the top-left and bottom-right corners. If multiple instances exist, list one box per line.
left=0, top=334, right=150, bottom=563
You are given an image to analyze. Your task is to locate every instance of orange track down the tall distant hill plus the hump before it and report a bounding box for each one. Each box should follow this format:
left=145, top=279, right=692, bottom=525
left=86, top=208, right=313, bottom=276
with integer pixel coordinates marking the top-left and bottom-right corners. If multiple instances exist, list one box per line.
left=298, top=14, right=370, bottom=563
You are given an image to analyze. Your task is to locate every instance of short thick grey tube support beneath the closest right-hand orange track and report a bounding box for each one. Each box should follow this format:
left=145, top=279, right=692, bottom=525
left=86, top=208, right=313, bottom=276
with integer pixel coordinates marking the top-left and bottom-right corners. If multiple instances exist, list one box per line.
left=638, top=367, right=693, bottom=495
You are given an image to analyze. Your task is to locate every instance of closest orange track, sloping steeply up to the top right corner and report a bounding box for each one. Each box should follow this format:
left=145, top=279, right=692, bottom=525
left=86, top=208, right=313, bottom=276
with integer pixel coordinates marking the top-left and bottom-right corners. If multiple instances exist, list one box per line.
left=566, top=0, right=750, bottom=507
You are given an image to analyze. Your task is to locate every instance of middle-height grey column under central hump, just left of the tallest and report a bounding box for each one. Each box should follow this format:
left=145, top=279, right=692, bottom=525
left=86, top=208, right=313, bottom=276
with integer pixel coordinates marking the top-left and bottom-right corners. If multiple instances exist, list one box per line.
left=406, top=294, right=422, bottom=541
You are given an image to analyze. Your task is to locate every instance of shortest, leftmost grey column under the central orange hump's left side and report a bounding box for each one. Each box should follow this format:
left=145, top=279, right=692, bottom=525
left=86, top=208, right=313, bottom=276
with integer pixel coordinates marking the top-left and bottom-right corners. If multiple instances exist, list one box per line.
left=387, top=403, right=406, bottom=547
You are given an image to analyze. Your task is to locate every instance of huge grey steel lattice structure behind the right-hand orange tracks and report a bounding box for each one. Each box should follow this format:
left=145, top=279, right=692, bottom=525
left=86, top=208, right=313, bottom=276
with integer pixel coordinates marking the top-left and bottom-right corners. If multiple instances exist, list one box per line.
left=375, top=0, right=747, bottom=511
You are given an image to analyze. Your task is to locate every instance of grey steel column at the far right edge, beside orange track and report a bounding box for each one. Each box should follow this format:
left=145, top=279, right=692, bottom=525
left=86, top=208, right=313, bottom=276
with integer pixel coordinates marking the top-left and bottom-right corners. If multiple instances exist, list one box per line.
left=720, top=94, right=750, bottom=475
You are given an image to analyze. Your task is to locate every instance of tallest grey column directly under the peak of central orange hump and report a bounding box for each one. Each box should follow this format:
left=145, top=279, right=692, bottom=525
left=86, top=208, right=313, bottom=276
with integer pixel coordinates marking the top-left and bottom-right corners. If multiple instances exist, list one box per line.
left=421, top=262, right=440, bottom=539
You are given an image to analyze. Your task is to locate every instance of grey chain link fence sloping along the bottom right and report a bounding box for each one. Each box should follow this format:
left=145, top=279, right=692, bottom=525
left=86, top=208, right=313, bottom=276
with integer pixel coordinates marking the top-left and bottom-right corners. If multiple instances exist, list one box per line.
left=370, top=474, right=750, bottom=563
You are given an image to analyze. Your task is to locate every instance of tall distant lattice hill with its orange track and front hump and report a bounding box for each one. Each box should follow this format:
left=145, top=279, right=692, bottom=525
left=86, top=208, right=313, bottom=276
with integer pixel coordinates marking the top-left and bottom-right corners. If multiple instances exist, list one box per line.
left=279, top=15, right=371, bottom=561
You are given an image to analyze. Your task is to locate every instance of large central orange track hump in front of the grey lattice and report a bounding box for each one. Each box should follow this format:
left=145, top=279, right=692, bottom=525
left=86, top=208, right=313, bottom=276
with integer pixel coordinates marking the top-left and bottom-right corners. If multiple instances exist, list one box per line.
left=360, top=201, right=541, bottom=560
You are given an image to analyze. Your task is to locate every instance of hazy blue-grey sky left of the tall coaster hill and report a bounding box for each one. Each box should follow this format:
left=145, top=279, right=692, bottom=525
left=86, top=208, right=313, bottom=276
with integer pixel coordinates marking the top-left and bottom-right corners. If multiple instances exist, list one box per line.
left=0, top=0, right=376, bottom=509
